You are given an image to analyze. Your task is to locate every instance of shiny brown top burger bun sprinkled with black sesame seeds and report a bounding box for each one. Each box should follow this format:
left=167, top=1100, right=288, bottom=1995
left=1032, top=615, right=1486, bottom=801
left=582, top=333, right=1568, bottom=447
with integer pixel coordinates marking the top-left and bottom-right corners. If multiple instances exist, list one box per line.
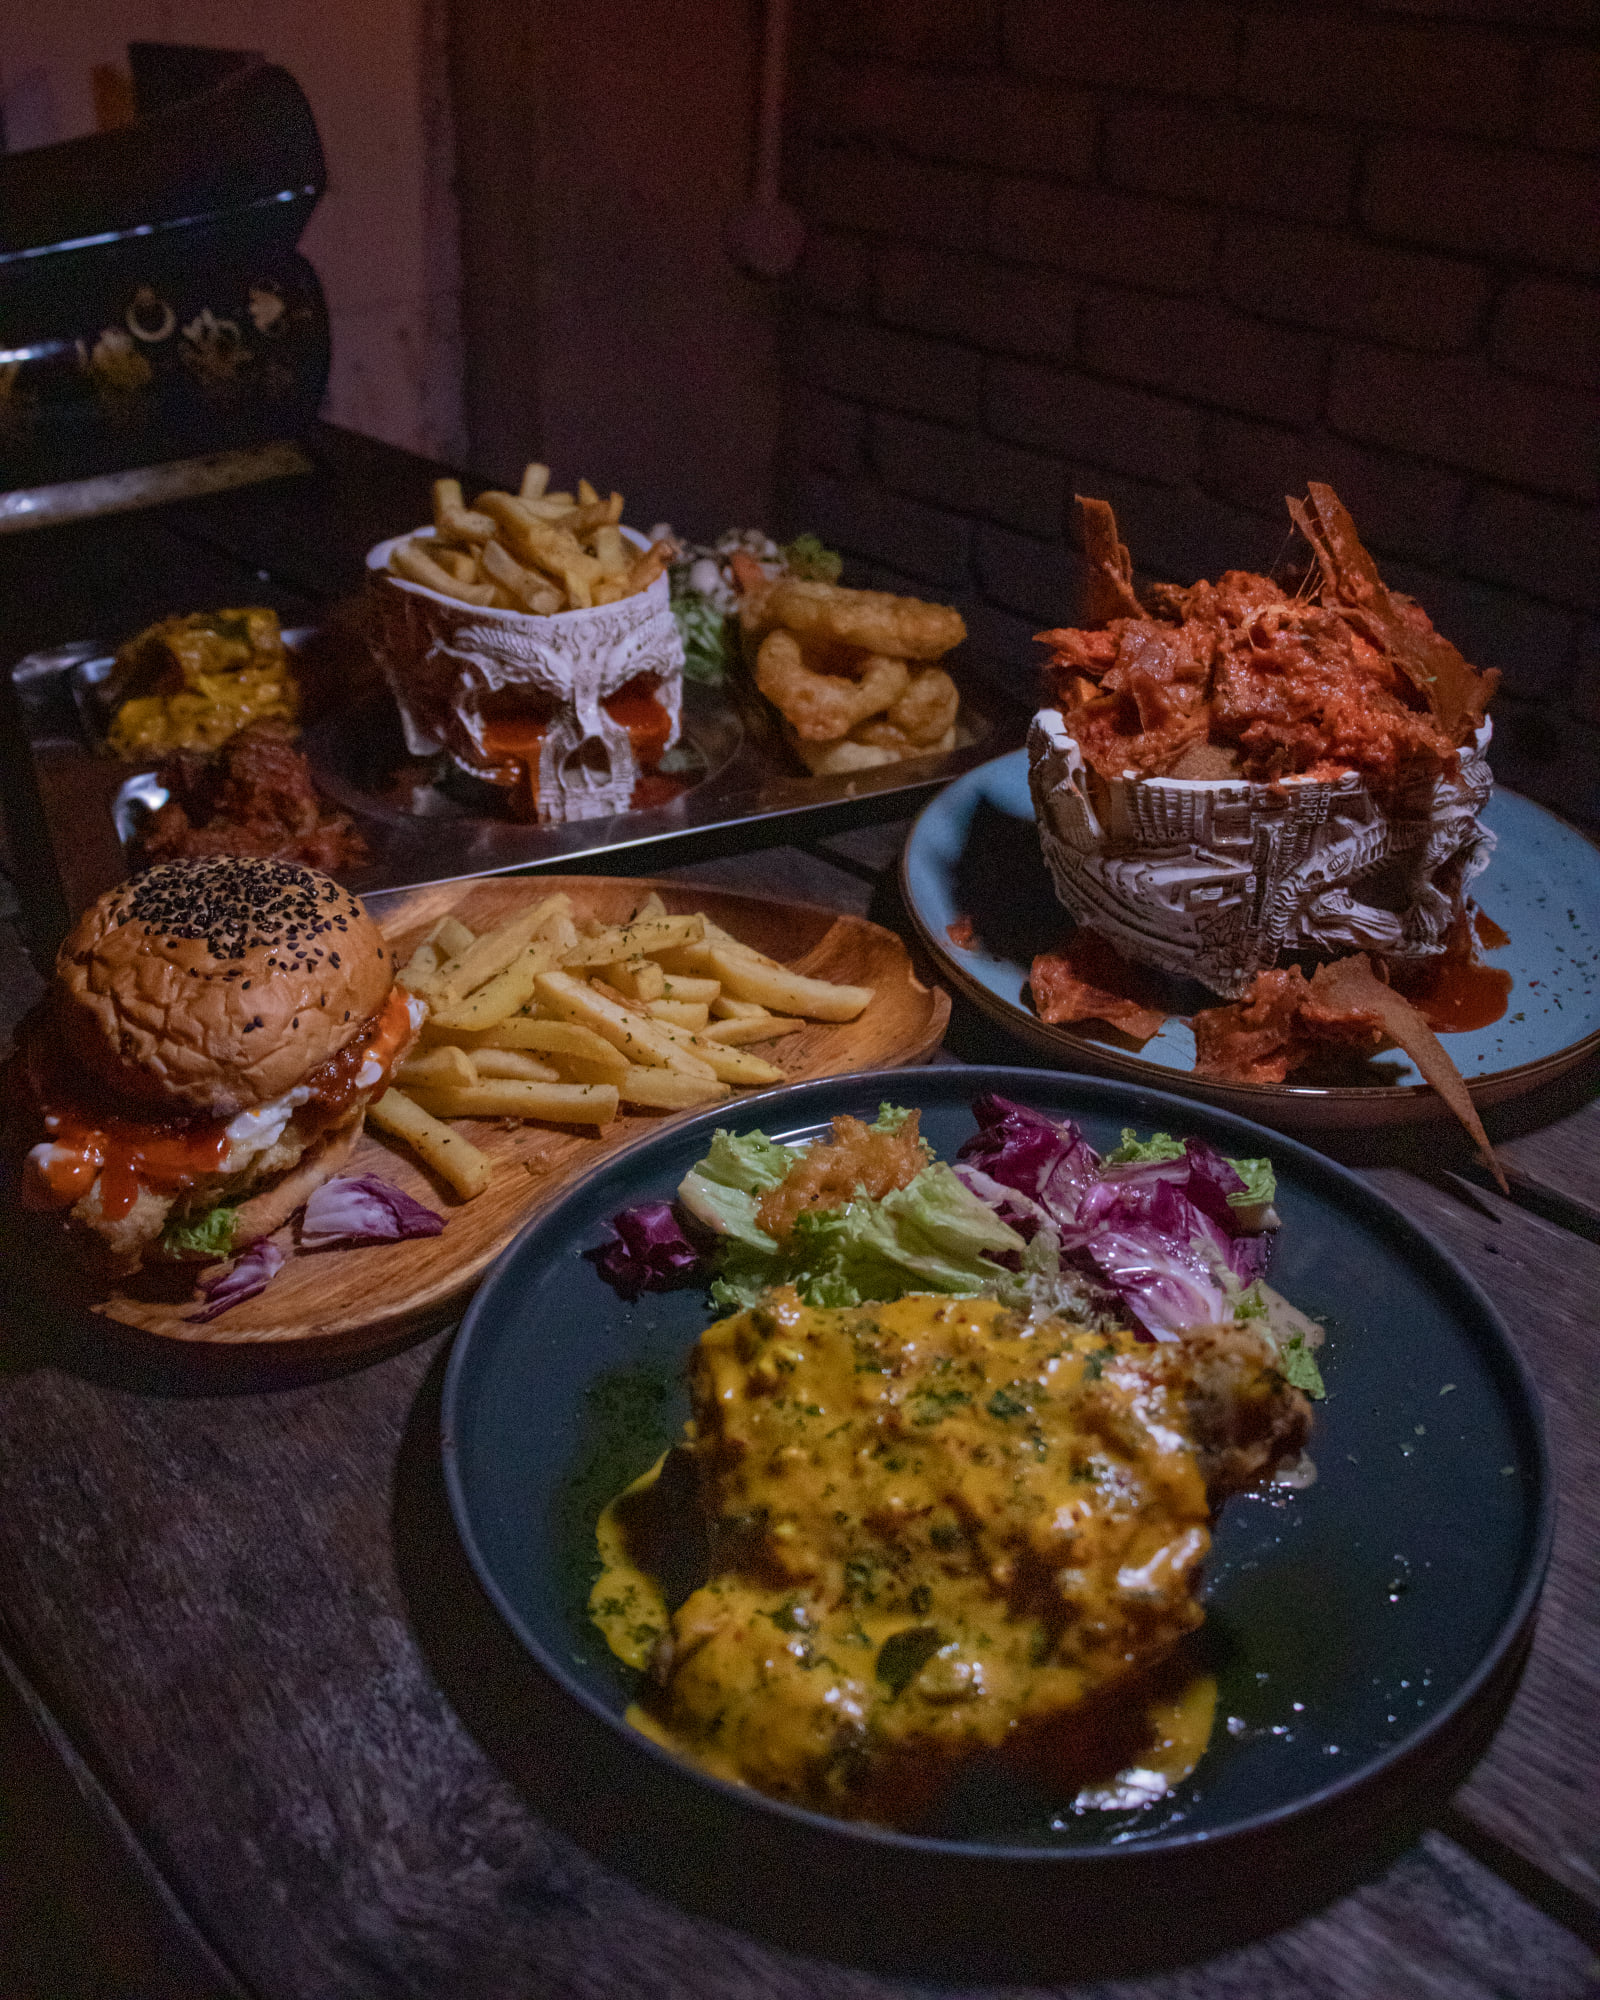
left=56, top=854, right=394, bottom=1118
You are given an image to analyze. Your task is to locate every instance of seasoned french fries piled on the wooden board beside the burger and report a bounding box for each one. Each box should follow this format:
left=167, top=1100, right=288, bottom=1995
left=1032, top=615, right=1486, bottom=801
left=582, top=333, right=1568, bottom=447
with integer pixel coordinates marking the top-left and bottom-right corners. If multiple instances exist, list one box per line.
left=368, top=896, right=872, bottom=1198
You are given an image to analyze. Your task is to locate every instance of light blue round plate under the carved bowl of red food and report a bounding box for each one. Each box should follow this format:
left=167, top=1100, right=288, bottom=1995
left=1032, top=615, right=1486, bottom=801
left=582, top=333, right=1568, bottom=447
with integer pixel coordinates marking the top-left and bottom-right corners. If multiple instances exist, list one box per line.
left=900, top=750, right=1600, bottom=1128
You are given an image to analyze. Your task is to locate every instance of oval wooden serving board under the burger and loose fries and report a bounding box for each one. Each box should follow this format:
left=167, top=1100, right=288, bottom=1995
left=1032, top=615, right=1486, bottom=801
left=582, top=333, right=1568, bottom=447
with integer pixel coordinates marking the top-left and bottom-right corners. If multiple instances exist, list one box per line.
left=94, top=874, right=950, bottom=1346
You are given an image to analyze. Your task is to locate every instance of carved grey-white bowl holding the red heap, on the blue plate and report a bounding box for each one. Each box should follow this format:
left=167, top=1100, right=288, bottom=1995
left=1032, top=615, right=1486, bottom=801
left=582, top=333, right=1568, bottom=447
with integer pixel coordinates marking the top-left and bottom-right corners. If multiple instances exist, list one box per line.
left=1028, top=708, right=1494, bottom=998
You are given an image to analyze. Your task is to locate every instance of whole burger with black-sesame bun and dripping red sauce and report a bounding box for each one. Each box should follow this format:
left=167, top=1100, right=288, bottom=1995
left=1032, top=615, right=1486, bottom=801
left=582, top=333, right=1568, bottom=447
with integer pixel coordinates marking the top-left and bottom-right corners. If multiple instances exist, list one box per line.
left=10, top=854, right=424, bottom=1272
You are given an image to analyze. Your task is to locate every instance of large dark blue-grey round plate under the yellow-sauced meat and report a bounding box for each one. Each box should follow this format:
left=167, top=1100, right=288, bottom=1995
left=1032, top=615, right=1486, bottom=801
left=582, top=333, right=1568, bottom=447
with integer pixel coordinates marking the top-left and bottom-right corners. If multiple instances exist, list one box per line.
left=444, top=1068, right=1552, bottom=1976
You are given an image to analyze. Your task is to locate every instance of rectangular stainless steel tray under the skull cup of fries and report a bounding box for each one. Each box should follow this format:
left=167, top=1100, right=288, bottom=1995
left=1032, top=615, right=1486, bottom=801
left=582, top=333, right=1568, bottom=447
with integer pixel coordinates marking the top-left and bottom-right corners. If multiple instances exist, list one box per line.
left=4, top=630, right=1026, bottom=946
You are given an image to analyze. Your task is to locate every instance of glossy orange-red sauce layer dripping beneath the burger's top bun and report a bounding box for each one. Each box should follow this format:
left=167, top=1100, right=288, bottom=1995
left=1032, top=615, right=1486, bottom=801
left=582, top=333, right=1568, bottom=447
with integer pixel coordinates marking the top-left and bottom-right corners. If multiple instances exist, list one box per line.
left=22, top=986, right=426, bottom=1222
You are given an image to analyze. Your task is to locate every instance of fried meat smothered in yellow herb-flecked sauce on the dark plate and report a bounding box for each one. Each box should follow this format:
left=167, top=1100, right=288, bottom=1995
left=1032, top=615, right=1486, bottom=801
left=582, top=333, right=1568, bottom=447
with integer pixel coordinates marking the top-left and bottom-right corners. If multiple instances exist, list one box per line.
left=592, top=1290, right=1310, bottom=1824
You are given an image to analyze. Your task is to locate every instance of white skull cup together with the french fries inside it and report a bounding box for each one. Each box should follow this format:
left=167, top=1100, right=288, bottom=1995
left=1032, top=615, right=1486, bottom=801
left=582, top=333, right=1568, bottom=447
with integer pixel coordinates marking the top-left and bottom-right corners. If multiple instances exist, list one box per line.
left=366, top=468, right=684, bottom=826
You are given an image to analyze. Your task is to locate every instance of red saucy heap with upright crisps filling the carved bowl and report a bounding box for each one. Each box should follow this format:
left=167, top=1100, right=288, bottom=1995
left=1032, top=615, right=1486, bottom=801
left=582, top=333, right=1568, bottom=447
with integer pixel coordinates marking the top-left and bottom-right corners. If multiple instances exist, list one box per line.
left=1040, top=484, right=1498, bottom=790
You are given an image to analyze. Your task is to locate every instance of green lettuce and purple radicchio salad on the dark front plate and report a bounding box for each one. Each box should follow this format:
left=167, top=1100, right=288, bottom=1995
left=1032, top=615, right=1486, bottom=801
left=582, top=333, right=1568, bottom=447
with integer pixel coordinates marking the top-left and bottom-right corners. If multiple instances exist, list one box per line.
left=598, top=1094, right=1322, bottom=1396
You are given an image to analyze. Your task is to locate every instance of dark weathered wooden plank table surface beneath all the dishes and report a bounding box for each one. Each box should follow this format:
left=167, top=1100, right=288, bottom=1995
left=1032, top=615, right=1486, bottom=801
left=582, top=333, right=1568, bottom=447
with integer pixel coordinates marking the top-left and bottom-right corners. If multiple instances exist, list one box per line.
left=0, top=432, right=1600, bottom=2000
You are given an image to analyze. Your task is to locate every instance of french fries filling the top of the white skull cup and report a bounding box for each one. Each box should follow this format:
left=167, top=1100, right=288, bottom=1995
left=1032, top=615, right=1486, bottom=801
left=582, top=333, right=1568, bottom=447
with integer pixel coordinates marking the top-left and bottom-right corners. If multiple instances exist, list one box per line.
left=388, top=464, right=672, bottom=616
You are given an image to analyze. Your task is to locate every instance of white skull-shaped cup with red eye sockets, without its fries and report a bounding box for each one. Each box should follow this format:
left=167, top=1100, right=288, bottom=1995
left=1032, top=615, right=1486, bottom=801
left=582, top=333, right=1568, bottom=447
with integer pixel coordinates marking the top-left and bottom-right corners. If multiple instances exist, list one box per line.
left=366, top=528, right=684, bottom=826
